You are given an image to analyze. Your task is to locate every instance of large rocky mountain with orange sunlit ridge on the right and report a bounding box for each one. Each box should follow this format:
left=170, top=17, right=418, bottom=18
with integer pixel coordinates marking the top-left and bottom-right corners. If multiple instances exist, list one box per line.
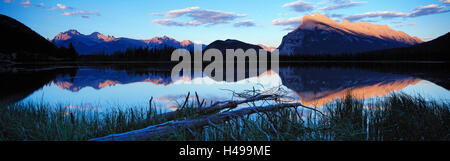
left=278, top=14, right=422, bottom=55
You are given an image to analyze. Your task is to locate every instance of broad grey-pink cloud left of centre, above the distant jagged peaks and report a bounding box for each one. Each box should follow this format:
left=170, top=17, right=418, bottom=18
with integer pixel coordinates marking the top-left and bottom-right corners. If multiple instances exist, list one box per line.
left=152, top=7, right=247, bottom=26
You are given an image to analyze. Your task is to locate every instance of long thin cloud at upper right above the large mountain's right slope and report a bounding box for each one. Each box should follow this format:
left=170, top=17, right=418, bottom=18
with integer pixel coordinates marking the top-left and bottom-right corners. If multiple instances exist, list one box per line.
left=345, top=4, right=449, bottom=21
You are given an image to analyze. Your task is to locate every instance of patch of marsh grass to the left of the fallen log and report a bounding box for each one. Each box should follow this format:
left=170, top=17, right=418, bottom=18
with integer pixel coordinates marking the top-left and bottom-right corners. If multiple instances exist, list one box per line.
left=0, top=104, right=165, bottom=141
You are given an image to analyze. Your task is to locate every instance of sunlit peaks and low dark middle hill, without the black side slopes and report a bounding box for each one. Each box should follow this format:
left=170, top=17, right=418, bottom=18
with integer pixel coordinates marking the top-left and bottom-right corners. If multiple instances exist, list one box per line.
left=52, top=14, right=422, bottom=55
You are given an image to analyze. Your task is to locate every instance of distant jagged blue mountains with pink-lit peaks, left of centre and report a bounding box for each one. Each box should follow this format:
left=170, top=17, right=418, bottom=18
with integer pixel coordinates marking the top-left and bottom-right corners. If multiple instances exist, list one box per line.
left=52, top=30, right=204, bottom=55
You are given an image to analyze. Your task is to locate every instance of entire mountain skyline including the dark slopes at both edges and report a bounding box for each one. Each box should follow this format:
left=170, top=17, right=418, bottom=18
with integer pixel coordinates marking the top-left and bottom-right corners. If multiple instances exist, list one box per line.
left=0, top=14, right=449, bottom=60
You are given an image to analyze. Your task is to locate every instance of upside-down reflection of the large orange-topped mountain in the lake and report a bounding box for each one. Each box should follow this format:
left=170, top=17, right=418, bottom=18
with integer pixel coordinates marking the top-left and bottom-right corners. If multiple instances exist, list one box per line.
left=280, top=68, right=422, bottom=107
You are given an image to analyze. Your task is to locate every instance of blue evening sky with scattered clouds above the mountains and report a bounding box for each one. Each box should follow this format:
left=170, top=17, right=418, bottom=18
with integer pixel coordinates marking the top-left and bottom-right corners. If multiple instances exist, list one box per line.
left=0, top=0, right=450, bottom=47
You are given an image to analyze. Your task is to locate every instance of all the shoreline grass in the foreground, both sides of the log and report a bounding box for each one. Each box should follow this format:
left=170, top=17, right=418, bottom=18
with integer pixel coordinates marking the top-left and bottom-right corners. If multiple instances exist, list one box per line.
left=0, top=94, right=450, bottom=141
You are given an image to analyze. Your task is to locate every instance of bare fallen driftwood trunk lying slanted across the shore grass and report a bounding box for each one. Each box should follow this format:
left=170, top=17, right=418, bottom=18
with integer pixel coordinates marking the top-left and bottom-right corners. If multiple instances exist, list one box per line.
left=89, top=102, right=317, bottom=141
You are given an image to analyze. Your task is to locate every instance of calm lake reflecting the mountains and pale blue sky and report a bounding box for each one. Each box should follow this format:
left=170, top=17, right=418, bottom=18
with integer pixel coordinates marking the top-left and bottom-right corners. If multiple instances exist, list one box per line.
left=0, top=62, right=450, bottom=111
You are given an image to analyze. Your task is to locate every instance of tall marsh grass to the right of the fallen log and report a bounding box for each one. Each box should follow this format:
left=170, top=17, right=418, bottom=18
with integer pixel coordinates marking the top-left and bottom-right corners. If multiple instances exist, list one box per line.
left=166, top=93, right=450, bottom=141
